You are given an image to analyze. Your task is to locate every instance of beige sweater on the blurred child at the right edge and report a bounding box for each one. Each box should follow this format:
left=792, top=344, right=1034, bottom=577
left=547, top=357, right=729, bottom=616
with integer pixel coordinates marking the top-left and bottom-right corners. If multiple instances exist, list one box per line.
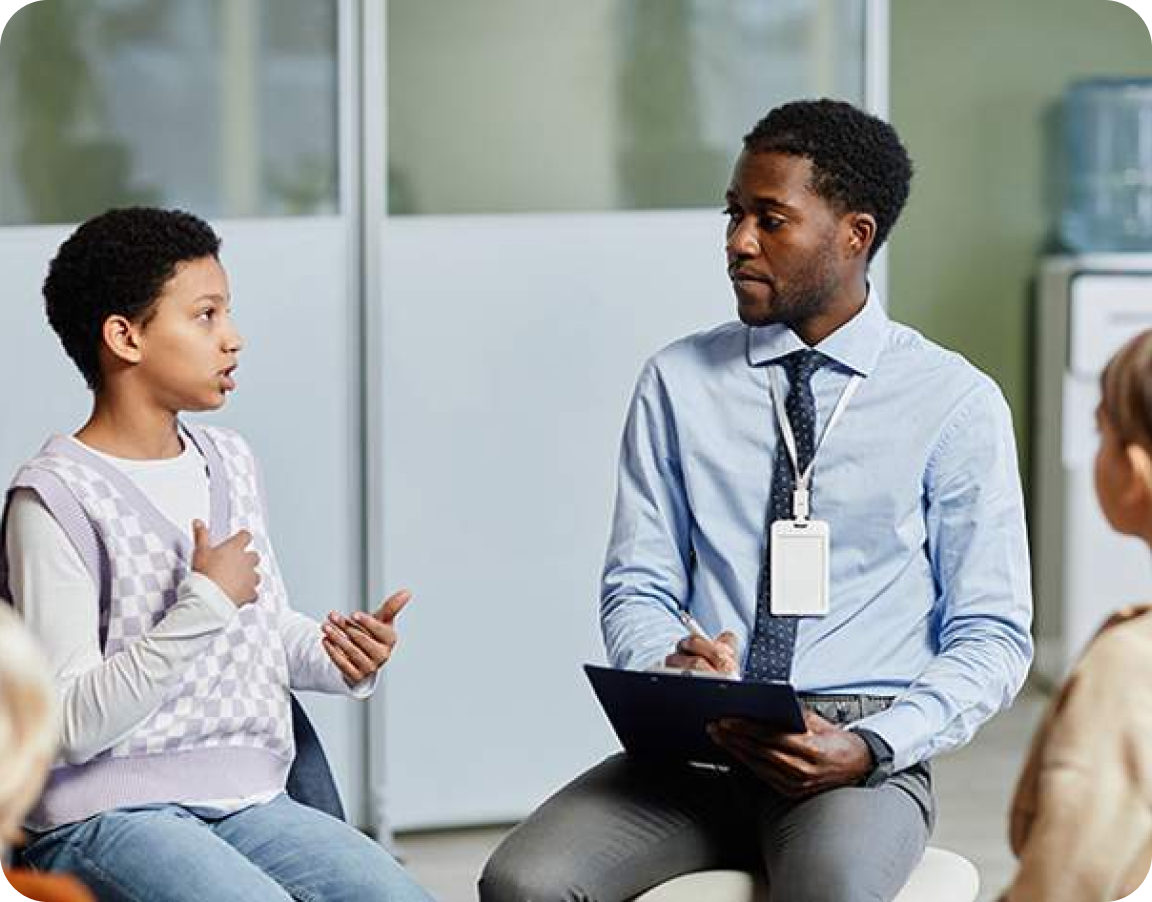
left=1001, top=606, right=1152, bottom=902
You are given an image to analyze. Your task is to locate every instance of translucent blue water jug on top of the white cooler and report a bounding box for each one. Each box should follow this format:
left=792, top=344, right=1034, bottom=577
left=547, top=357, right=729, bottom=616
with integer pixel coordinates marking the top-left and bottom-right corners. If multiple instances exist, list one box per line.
left=1060, top=78, right=1152, bottom=251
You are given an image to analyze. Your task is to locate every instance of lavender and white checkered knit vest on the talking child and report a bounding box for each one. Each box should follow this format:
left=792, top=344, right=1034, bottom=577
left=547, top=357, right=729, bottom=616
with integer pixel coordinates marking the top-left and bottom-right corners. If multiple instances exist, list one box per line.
left=0, top=426, right=295, bottom=829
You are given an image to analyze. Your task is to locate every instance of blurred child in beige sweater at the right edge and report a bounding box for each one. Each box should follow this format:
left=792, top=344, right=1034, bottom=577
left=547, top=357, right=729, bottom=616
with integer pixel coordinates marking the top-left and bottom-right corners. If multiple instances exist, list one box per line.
left=1001, top=332, right=1152, bottom=902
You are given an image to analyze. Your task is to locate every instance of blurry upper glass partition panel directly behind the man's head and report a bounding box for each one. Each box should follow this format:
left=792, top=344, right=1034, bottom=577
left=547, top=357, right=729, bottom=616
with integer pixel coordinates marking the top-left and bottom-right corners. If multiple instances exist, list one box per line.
left=387, top=0, right=866, bottom=214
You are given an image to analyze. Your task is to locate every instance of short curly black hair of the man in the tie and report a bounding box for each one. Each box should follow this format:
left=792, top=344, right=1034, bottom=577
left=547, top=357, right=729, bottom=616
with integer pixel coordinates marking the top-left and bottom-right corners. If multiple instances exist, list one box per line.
left=744, top=99, right=912, bottom=260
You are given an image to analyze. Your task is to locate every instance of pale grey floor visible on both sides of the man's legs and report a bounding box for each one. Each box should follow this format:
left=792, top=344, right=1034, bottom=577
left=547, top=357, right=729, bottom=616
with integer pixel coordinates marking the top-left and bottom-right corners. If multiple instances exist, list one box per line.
left=397, top=690, right=1045, bottom=902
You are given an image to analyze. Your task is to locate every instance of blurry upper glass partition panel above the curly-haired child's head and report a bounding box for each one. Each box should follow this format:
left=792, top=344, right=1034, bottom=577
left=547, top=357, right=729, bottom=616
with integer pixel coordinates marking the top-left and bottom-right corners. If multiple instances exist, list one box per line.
left=0, top=0, right=338, bottom=225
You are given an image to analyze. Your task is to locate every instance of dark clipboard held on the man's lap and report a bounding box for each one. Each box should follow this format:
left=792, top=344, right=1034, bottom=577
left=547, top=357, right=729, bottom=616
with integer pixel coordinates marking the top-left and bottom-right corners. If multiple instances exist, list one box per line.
left=584, top=664, right=806, bottom=765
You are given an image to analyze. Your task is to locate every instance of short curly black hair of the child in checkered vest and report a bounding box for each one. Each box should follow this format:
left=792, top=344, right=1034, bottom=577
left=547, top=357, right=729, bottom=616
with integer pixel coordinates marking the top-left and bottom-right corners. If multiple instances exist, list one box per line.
left=44, top=207, right=220, bottom=392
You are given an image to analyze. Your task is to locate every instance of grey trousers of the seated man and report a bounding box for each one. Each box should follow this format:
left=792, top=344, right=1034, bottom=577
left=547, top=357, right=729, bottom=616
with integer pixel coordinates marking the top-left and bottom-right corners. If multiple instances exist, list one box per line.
left=479, top=700, right=935, bottom=902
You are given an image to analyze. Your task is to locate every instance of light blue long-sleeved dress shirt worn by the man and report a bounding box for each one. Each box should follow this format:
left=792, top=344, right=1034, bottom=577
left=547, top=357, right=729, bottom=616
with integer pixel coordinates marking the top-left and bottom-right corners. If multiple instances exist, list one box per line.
left=600, top=291, right=1032, bottom=770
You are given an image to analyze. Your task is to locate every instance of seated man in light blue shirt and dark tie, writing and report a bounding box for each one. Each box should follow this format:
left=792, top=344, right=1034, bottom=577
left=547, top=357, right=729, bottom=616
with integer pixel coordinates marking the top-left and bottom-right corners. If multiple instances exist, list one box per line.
left=480, top=100, right=1032, bottom=902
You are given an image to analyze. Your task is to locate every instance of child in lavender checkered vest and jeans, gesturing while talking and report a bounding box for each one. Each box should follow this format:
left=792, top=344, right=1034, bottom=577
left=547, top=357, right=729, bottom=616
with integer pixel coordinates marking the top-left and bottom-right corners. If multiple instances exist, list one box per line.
left=0, top=209, right=429, bottom=902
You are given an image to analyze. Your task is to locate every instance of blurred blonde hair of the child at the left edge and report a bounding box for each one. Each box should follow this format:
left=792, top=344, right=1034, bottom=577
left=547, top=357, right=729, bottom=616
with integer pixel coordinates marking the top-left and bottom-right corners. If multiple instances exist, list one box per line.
left=0, top=600, right=59, bottom=851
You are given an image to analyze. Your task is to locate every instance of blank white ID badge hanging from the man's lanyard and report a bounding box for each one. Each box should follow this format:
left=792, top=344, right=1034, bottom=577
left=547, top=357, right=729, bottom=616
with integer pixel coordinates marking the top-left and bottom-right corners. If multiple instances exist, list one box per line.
left=768, top=520, right=829, bottom=617
